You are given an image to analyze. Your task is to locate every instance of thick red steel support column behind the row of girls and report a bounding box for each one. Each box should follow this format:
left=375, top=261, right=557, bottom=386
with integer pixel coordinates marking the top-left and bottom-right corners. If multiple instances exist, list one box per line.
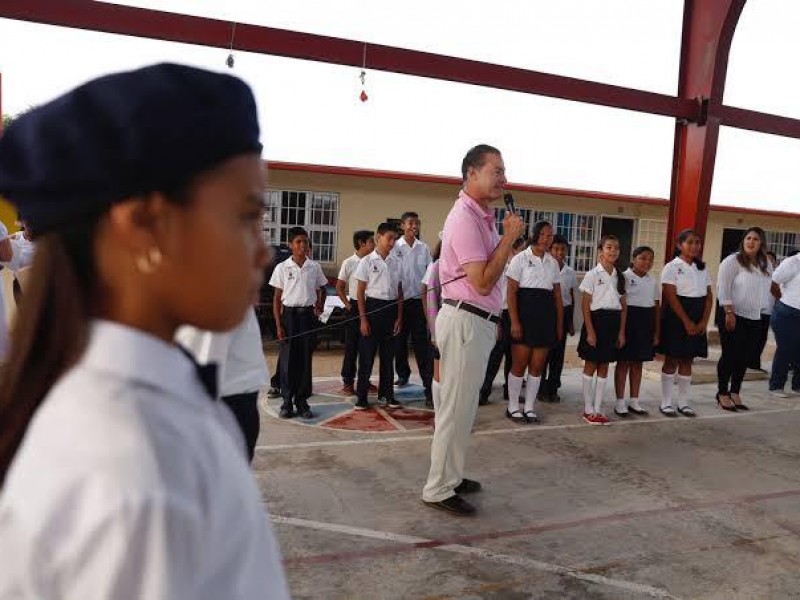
left=666, top=0, right=746, bottom=258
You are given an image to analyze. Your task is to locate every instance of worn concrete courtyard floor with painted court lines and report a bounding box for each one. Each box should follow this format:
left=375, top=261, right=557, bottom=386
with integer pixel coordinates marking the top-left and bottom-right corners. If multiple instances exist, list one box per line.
left=253, top=342, right=800, bottom=599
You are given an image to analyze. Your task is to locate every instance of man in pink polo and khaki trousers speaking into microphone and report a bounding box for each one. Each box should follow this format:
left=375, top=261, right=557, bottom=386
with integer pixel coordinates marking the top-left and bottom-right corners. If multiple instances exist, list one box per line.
left=422, top=144, right=525, bottom=516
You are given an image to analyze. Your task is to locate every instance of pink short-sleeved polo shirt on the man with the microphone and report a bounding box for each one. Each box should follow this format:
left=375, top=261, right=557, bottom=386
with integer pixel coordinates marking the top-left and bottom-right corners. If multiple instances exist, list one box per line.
left=439, top=190, right=503, bottom=313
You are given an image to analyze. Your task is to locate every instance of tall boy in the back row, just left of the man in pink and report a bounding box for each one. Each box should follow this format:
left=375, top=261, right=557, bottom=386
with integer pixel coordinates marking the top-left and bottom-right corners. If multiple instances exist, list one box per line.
left=392, top=211, right=433, bottom=402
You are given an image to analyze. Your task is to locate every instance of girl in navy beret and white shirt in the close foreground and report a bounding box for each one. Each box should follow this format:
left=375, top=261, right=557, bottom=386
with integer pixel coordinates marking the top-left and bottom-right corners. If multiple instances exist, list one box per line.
left=0, top=64, right=289, bottom=600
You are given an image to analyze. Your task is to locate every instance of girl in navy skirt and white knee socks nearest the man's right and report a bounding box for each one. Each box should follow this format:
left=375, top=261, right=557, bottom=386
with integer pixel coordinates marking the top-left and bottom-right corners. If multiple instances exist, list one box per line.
left=506, top=221, right=564, bottom=423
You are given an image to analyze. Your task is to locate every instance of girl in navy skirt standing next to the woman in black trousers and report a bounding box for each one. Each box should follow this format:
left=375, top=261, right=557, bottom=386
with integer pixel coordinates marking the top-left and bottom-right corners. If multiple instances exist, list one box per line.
left=660, top=229, right=713, bottom=417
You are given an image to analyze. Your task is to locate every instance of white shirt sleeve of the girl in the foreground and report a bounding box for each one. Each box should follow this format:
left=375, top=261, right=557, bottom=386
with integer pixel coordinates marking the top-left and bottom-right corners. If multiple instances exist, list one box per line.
left=52, top=498, right=203, bottom=600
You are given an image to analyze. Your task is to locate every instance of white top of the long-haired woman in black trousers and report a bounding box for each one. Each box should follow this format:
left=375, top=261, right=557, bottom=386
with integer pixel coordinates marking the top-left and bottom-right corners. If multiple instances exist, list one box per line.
left=717, top=253, right=772, bottom=321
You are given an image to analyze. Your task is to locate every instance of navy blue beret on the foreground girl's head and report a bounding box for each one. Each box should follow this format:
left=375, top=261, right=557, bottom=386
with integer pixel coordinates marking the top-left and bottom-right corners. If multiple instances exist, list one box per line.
left=0, top=64, right=261, bottom=235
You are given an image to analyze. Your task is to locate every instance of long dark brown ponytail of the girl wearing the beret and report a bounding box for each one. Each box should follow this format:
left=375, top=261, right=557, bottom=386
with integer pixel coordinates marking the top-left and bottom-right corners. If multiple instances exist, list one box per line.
left=0, top=219, right=97, bottom=487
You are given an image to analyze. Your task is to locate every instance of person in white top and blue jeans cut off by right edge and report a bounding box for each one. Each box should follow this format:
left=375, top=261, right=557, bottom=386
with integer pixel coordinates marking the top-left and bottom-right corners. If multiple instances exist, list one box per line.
left=769, top=246, right=800, bottom=398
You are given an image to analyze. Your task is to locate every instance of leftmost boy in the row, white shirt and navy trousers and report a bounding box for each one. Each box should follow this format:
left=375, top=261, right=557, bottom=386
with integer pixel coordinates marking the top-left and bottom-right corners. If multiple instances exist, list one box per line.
left=269, top=227, right=328, bottom=419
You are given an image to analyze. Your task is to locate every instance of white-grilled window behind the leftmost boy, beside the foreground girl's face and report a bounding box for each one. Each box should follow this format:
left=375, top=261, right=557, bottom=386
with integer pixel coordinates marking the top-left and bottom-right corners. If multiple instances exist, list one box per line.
left=263, top=190, right=339, bottom=263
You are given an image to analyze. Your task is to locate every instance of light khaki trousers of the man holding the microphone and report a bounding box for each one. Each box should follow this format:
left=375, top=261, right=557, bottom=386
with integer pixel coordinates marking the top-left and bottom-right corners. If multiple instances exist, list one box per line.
left=422, top=304, right=497, bottom=502
